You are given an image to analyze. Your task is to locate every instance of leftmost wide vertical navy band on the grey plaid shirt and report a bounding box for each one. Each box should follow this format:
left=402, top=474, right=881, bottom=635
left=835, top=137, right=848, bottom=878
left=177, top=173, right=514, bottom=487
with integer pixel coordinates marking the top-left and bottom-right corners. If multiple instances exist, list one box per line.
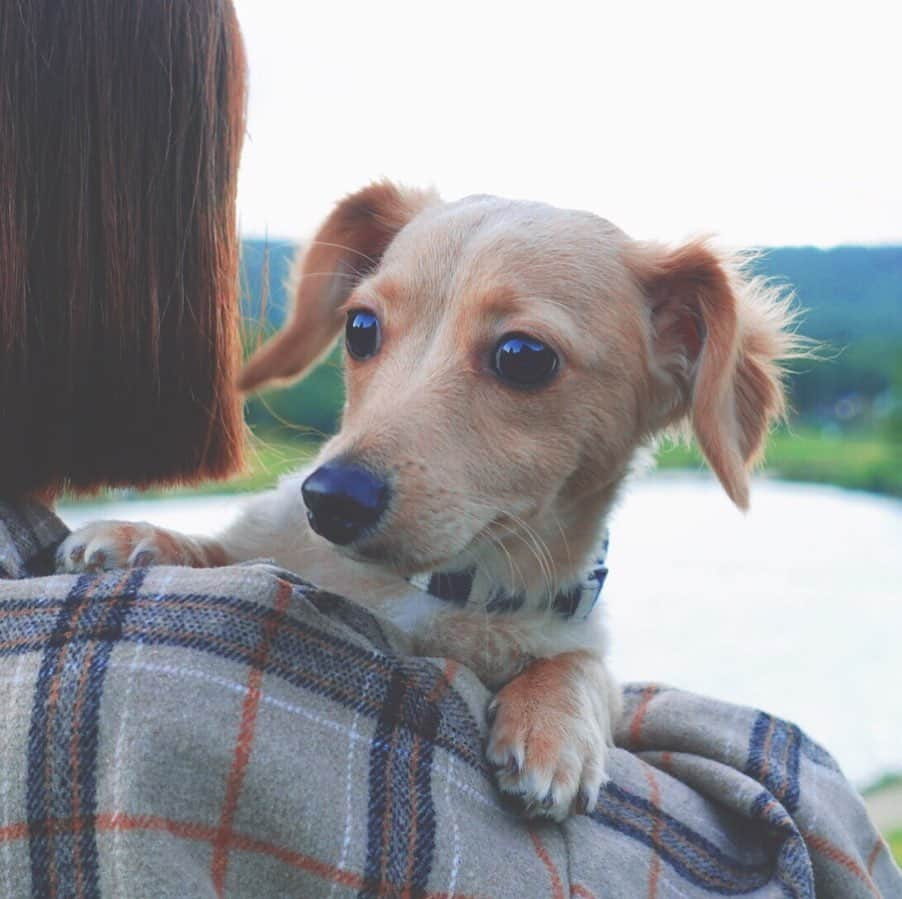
left=26, top=569, right=146, bottom=899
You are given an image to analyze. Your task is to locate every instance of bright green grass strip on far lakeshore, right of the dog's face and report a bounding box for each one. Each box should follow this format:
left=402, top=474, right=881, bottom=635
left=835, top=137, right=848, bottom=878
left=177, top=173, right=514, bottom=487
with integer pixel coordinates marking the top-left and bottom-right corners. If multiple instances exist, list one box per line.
left=658, top=427, right=902, bottom=497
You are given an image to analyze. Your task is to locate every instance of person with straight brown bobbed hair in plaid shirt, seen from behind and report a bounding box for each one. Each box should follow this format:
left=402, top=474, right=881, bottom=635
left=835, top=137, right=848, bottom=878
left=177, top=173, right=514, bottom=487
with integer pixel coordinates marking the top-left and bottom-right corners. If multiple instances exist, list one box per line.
left=0, top=0, right=902, bottom=899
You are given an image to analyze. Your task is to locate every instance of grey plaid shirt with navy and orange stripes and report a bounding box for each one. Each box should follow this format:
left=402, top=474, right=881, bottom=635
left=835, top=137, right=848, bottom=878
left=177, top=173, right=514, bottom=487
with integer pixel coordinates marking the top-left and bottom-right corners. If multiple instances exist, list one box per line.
left=0, top=506, right=902, bottom=899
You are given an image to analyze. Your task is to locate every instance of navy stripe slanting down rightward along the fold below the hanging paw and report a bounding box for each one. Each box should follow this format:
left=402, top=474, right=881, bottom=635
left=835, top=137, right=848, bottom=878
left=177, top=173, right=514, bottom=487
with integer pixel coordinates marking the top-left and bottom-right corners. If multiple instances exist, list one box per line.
left=590, top=783, right=773, bottom=896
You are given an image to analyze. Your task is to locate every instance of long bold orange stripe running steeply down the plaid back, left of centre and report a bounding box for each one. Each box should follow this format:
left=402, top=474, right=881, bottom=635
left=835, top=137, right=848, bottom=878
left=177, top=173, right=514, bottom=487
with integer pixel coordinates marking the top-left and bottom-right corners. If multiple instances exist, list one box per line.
left=210, top=581, right=291, bottom=896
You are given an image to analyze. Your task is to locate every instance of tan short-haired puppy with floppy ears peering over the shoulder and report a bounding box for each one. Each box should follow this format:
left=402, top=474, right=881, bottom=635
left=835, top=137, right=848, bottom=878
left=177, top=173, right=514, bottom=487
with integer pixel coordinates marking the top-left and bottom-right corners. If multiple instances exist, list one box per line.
left=59, top=182, right=794, bottom=820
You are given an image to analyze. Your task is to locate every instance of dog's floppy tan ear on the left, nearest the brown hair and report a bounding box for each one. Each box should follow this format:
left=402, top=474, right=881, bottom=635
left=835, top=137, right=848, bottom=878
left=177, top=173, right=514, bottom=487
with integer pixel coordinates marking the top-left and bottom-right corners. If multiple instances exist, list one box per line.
left=238, top=181, right=438, bottom=391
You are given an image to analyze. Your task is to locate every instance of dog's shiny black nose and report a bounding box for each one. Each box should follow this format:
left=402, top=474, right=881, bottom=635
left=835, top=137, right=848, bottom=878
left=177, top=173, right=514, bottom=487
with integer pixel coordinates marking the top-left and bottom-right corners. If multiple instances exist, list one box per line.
left=301, top=461, right=388, bottom=546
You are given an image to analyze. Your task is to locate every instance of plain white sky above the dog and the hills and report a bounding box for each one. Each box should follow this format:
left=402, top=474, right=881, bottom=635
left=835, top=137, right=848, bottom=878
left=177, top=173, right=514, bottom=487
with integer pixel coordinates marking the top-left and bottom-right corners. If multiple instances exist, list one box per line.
left=235, top=0, right=902, bottom=246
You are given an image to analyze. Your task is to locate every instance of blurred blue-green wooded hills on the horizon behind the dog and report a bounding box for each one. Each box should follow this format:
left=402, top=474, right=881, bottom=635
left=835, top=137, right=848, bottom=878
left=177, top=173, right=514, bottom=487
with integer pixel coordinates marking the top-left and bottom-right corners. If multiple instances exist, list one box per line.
left=242, top=240, right=902, bottom=442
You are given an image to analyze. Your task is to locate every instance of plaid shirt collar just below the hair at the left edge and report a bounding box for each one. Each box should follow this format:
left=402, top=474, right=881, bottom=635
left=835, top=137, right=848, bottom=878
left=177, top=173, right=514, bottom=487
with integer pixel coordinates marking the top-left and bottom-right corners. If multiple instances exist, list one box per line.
left=0, top=500, right=69, bottom=580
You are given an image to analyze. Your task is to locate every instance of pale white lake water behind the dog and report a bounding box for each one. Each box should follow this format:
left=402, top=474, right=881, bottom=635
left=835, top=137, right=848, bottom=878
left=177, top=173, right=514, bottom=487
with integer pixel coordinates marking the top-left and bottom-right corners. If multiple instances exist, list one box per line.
left=62, top=474, right=902, bottom=785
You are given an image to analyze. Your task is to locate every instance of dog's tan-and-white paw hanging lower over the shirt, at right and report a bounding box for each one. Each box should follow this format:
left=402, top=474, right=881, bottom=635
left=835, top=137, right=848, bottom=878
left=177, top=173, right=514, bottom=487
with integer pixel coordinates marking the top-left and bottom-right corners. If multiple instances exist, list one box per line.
left=487, top=652, right=616, bottom=821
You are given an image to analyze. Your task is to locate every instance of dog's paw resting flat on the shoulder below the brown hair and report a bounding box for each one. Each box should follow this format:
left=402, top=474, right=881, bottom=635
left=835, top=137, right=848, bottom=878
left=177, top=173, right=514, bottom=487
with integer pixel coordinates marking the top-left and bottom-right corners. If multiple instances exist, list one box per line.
left=56, top=521, right=192, bottom=572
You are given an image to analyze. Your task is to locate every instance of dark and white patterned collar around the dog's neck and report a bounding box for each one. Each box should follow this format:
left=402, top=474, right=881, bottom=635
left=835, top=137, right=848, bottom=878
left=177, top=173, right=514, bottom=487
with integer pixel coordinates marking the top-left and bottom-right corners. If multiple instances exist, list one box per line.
left=407, top=534, right=608, bottom=620
